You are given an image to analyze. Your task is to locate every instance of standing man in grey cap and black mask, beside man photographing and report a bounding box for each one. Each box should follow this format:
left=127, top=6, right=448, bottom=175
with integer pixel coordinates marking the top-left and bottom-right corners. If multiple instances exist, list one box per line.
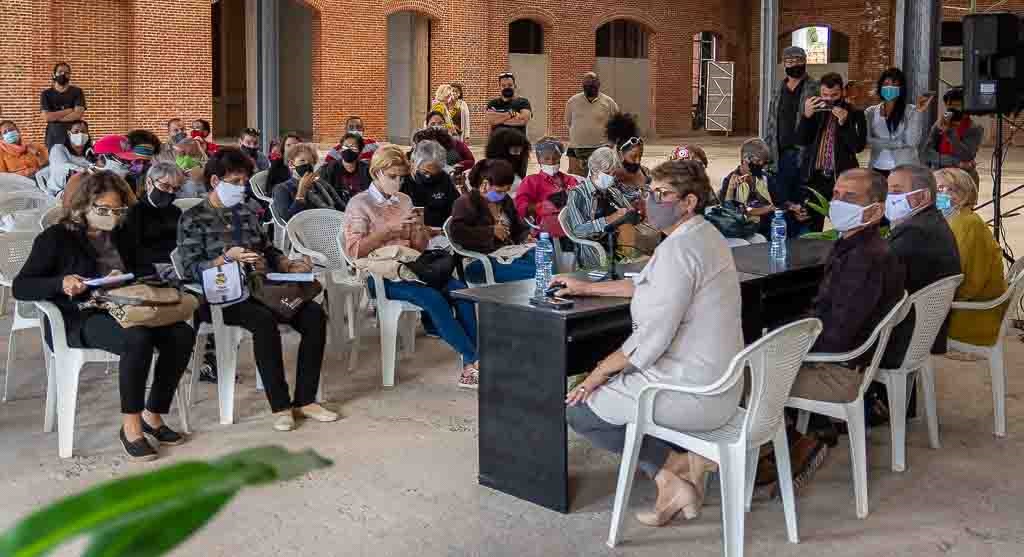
left=763, top=46, right=820, bottom=219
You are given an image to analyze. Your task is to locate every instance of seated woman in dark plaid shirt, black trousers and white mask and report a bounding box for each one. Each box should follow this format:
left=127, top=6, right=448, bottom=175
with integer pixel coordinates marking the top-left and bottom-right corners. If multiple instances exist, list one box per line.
left=178, top=147, right=338, bottom=431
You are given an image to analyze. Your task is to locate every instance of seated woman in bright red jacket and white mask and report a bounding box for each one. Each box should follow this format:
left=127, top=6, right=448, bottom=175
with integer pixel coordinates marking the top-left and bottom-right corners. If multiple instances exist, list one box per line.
left=515, top=137, right=580, bottom=239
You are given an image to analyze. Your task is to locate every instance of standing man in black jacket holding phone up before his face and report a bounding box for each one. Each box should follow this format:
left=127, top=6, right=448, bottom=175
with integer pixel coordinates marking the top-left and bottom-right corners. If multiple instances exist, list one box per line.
left=797, top=74, right=867, bottom=231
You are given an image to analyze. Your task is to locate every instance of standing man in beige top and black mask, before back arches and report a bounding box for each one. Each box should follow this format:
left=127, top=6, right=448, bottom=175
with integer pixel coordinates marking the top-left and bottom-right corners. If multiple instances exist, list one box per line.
left=565, top=72, right=618, bottom=176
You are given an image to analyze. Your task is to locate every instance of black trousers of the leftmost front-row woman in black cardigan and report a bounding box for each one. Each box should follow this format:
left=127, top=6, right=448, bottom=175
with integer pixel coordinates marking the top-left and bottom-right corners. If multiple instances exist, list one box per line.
left=82, top=313, right=196, bottom=414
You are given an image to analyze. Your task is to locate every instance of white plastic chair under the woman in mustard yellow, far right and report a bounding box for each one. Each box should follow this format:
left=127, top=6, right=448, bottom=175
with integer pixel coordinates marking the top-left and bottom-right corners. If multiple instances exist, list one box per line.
left=949, top=258, right=1024, bottom=437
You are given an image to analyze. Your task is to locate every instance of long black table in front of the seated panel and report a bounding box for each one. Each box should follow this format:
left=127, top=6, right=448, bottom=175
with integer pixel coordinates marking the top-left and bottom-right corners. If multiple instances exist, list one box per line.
left=454, top=240, right=831, bottom=513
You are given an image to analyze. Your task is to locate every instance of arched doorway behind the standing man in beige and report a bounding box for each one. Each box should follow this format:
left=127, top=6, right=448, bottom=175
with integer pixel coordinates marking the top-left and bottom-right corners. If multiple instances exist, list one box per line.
left=594, top=19, right=650, bottom=135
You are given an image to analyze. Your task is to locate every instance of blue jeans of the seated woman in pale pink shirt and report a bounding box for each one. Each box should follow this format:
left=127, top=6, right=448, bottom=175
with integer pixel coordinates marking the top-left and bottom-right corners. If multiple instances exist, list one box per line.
left=385, top=279, right=479, bottom=365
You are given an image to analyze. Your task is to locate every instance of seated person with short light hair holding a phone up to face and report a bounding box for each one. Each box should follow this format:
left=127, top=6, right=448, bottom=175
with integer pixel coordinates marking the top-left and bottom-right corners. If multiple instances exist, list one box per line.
left=272, top=143, right=346, bottom=222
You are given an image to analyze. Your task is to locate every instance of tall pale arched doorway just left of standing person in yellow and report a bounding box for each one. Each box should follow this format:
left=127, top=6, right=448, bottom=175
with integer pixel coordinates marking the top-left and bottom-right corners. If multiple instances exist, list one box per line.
left=387, top=11, right=432, bottom=144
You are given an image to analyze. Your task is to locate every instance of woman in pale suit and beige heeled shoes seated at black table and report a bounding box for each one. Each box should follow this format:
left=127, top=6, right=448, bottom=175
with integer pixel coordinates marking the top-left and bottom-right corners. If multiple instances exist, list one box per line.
left=554, top=161, right=743, bottom=526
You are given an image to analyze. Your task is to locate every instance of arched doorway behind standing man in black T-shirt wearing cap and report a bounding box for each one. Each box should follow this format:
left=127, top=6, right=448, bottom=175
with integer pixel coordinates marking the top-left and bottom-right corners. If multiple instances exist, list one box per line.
left=509, top=19, right=548, bottom=141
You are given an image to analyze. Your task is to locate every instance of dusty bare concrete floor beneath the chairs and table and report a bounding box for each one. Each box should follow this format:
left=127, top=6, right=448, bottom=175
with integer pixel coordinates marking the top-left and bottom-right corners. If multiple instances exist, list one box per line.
left=0, top=139, right=1024, bottom=557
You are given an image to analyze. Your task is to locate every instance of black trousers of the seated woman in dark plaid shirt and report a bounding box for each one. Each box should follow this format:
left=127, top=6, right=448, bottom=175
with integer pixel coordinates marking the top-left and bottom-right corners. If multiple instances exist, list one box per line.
left=200, top=299, right=327, bottom=412
